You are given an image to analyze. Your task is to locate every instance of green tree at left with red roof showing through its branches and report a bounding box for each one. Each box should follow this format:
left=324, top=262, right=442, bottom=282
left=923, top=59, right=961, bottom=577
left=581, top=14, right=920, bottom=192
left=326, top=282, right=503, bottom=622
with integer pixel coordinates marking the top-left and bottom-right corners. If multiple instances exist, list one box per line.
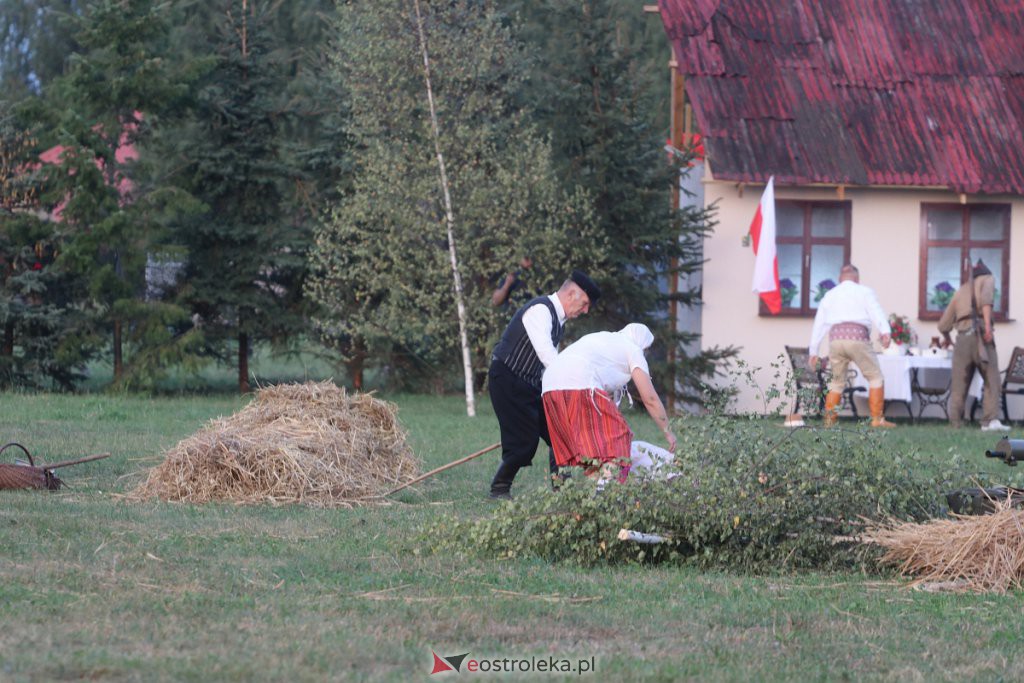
left=26, top=0, right=196, bottom=385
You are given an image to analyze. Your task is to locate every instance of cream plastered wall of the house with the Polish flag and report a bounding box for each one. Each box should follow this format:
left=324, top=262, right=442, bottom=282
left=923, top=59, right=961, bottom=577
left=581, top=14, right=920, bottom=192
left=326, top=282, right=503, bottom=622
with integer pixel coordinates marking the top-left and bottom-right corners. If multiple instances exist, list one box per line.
left=700, top=180, right=1024, bottom=416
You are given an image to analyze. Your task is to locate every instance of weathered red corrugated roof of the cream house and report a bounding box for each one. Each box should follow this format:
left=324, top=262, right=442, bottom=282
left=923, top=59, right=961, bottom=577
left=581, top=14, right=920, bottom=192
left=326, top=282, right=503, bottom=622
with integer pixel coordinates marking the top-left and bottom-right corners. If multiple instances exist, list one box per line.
left=658, top=0, right=1024, bottom=195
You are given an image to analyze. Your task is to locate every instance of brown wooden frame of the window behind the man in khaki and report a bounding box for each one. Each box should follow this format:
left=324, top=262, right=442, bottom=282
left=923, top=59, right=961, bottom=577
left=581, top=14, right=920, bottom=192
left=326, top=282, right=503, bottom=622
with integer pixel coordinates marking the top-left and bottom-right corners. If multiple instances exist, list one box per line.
left=918, top=202, right=1011, bottom=323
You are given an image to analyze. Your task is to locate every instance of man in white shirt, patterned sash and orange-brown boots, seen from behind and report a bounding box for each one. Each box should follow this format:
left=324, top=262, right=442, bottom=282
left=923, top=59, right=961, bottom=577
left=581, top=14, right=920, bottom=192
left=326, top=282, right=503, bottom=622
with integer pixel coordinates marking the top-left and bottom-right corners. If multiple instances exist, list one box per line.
left=809, top=263, right=896, bottom=427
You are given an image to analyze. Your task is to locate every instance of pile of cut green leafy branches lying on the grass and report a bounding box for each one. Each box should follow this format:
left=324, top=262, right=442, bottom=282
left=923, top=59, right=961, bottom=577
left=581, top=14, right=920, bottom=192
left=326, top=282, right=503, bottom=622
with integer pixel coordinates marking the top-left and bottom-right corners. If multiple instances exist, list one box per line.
left=430, top=417, right=963, bottom=572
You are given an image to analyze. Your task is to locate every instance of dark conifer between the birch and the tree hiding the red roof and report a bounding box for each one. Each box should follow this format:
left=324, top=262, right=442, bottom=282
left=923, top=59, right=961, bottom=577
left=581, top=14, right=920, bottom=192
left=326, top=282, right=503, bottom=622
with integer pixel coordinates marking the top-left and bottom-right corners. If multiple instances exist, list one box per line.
left=172, top=0, right=310, bottom=392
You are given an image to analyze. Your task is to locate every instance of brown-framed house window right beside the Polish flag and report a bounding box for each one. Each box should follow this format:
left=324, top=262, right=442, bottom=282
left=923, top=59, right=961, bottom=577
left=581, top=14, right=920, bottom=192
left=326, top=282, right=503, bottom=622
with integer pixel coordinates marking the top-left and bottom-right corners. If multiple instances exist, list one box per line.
left=761, top=200, right=850, bottom=316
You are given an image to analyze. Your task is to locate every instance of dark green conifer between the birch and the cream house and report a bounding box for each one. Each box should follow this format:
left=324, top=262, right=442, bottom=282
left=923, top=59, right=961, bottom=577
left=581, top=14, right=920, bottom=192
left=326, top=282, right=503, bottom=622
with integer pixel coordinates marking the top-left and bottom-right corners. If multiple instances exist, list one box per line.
left=517, top=0, right=733, bottom=400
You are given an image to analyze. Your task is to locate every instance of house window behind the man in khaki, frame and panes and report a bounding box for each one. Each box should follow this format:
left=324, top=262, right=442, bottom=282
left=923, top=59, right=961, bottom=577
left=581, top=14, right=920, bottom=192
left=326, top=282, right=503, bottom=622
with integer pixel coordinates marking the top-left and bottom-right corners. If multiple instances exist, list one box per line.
left=918, top=204, right=1010, bottom=321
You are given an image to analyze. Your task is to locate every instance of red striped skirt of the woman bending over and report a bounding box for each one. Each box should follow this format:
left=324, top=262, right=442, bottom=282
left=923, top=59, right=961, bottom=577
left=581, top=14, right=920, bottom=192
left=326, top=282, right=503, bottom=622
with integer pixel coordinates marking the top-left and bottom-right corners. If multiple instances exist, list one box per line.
left=544, top=389, right=633, bottom=468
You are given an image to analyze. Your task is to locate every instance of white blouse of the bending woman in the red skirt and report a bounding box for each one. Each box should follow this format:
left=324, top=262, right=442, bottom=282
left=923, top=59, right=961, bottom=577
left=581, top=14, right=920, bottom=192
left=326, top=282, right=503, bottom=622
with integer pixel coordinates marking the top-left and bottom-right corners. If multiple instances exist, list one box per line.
left=543, top=332, right=650, bottom=394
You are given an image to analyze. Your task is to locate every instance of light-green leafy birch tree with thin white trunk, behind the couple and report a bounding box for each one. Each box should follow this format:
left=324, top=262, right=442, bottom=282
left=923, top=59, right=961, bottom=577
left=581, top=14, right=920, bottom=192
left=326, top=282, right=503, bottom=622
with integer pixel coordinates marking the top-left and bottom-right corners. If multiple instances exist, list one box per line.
left=307, top=0, right=606, bottom=395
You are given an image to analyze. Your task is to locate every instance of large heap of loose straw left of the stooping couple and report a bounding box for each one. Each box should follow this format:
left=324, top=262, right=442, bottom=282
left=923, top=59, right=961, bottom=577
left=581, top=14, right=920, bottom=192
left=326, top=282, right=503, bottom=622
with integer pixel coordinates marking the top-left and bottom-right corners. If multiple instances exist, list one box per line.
left=129, top=382, right=419, bottom=507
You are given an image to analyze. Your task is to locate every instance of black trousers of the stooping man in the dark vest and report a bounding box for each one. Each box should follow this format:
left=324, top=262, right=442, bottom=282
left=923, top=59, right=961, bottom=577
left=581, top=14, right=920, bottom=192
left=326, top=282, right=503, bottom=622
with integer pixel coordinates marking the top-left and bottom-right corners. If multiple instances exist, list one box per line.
left=487, top=360, right=551, bottom=467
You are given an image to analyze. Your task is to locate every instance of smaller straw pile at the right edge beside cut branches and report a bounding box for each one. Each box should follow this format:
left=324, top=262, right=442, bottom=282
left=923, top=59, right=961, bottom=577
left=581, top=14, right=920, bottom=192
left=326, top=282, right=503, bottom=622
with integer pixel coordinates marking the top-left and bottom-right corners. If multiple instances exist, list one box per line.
left=862, top=501, right=1024, bottom=593
